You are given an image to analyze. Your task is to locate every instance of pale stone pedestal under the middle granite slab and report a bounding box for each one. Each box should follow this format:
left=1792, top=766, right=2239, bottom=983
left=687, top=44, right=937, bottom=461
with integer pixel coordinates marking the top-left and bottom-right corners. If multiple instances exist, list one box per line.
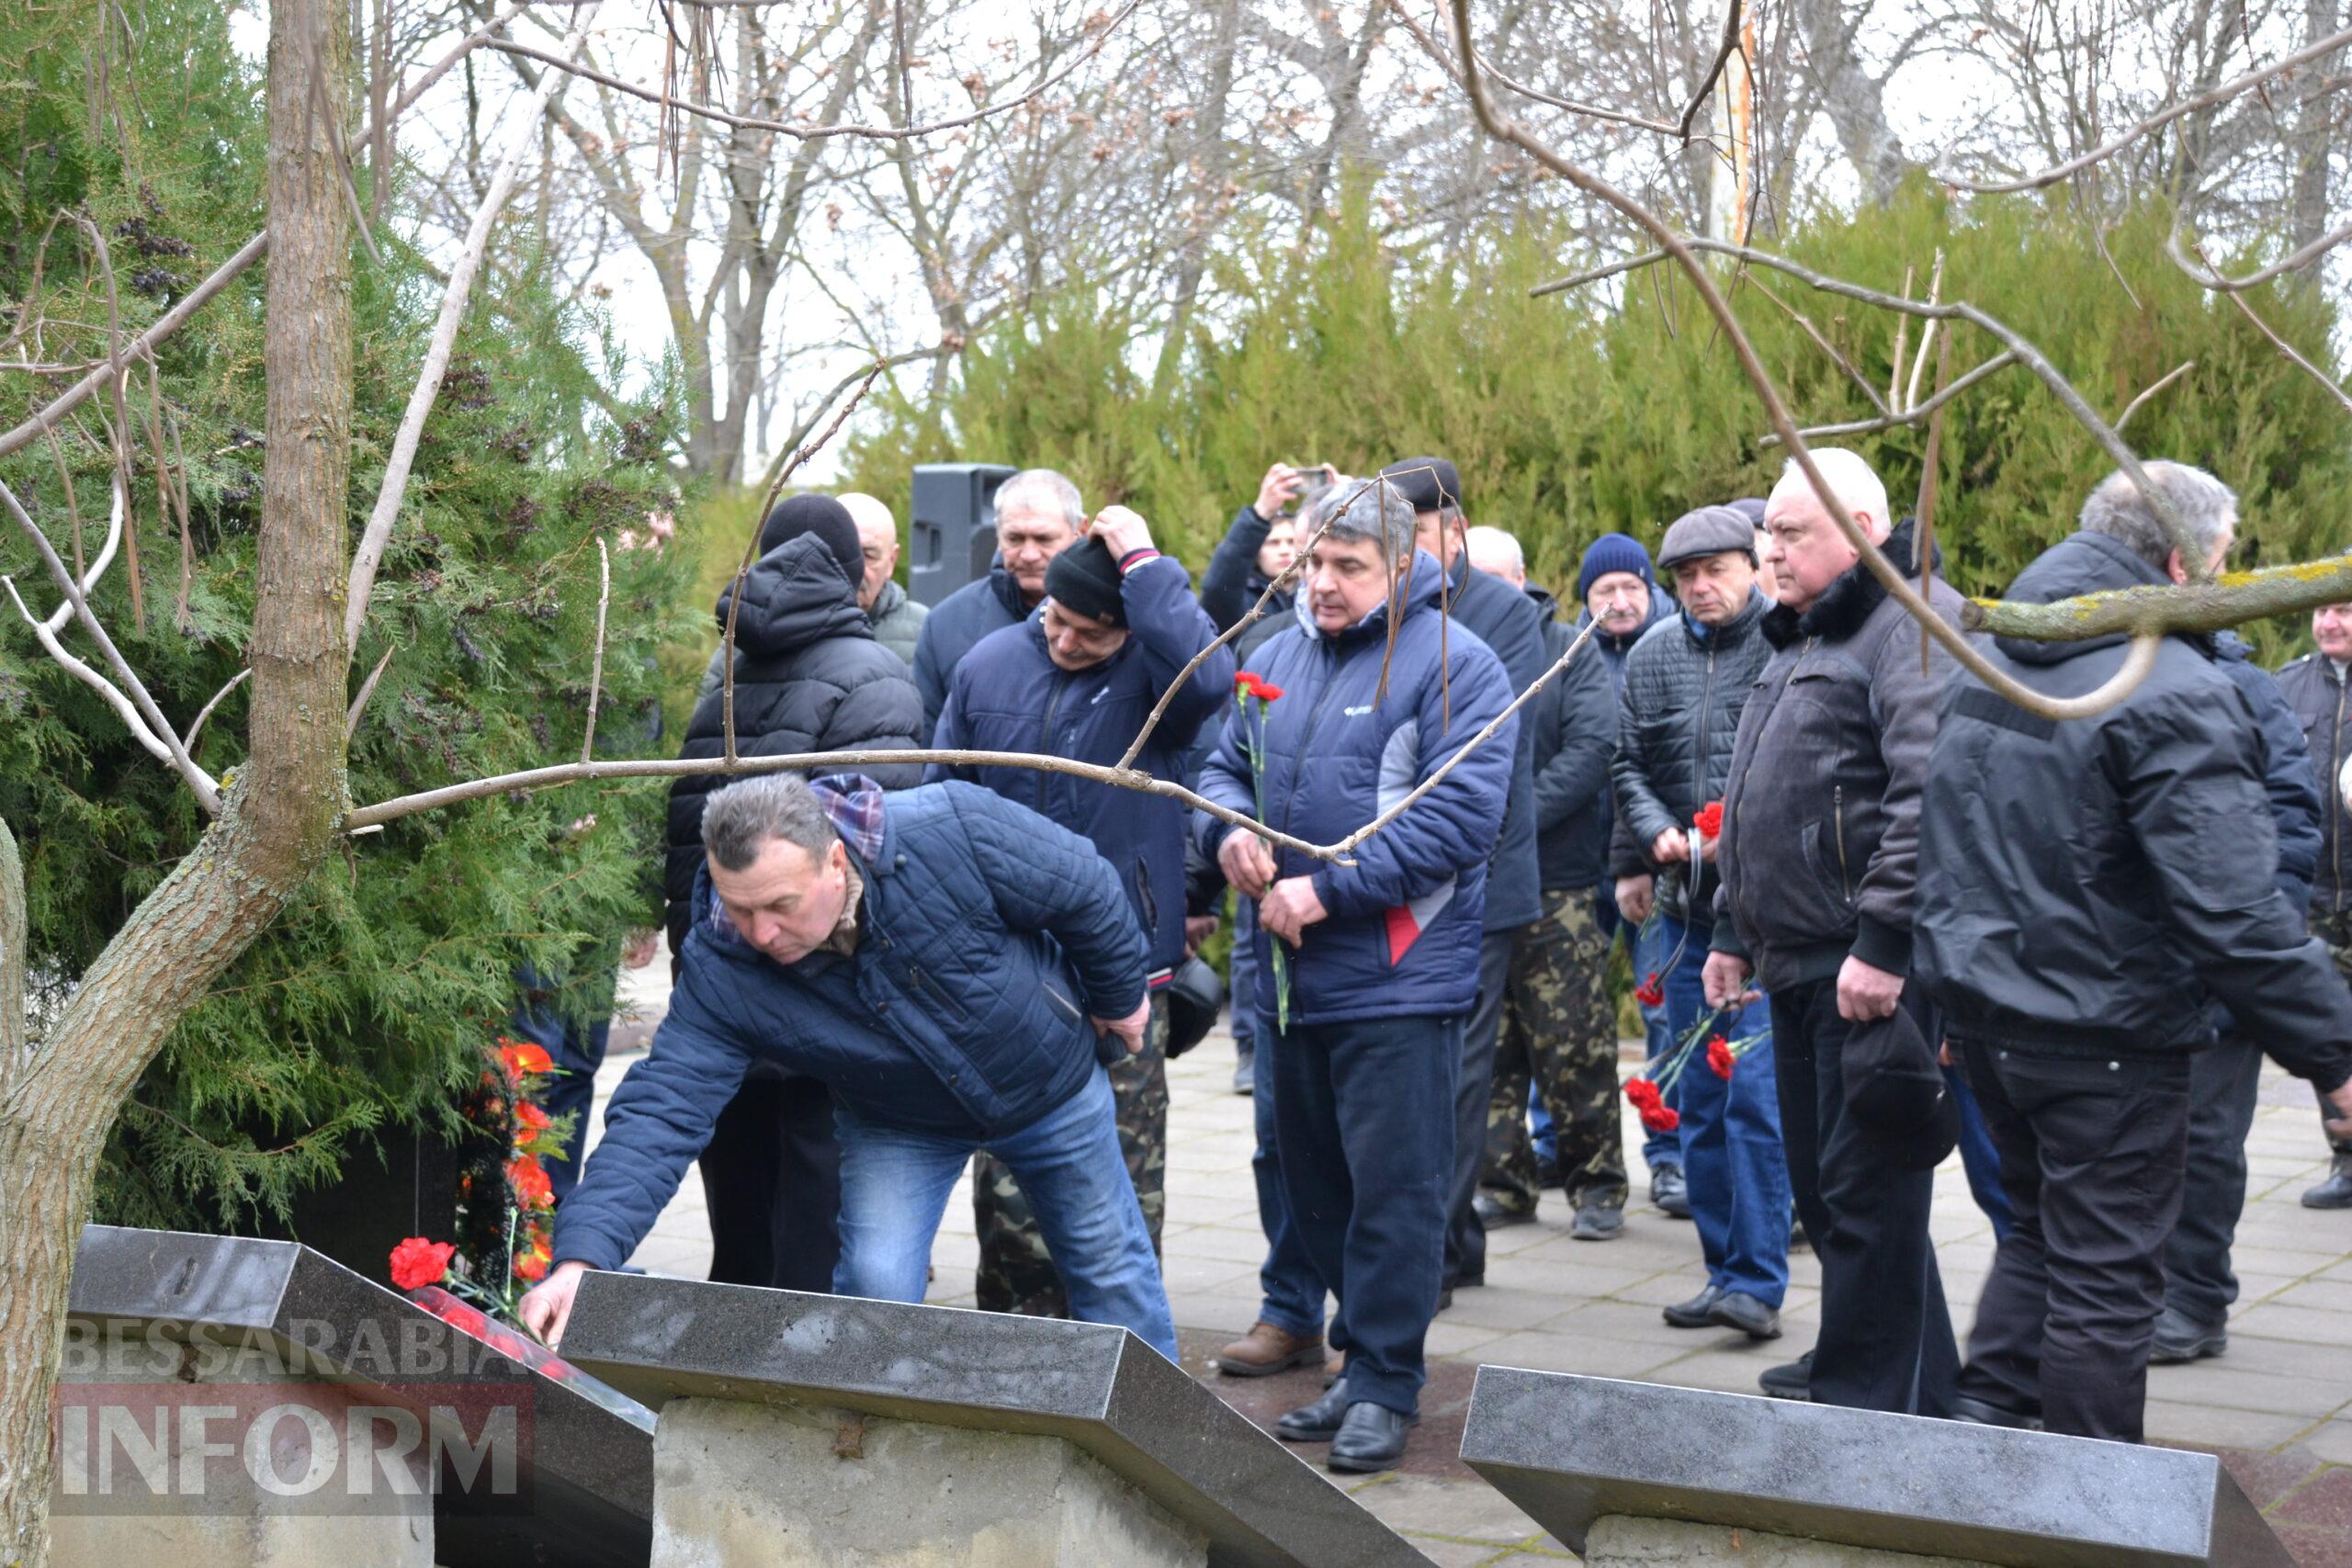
left=654, top=1399, right=1209, bottom=1568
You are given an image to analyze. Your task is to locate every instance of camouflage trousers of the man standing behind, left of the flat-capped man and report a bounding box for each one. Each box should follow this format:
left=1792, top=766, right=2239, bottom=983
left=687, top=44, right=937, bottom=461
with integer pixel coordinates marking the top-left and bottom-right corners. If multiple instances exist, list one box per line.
left=1479, top=888, right=1625, bottom=1213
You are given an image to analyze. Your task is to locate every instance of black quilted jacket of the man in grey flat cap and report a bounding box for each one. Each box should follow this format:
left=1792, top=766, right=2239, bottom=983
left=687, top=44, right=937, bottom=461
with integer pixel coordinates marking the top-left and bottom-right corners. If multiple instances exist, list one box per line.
left=1609, top=592, right=1771, bottom=926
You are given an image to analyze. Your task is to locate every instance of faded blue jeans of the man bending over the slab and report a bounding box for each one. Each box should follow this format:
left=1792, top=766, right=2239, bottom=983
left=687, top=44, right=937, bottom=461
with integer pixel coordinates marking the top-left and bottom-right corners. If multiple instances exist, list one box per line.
left=832, top=1067, right=1176, bottom=1361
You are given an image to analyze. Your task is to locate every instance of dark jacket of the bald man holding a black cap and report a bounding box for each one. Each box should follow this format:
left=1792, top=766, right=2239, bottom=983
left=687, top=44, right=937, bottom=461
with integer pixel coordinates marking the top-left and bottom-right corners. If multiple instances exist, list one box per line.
left=1714, top=522, right=1959, bottom=992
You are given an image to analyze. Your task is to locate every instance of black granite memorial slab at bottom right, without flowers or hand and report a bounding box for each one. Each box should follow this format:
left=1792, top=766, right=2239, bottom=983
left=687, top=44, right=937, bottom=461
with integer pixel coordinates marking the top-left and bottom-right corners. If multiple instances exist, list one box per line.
left=1463, top=1366, right=2293, bottom=1568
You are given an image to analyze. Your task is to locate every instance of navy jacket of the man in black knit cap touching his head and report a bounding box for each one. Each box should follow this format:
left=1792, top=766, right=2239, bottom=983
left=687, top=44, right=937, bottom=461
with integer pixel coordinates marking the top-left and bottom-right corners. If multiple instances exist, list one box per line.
left=924, top=555, right=1232, bottom=971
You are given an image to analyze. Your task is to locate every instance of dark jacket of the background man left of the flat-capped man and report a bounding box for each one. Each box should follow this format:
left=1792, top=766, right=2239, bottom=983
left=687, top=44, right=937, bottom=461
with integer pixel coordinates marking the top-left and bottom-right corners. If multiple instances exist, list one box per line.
left=1520, top=588, right=1616, bottom=894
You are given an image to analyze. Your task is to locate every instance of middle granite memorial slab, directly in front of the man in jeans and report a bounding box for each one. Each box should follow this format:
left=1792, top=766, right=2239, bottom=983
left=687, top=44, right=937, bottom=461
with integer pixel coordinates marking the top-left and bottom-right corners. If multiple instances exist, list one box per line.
left=564, top=1274, right=1428, bottom=1568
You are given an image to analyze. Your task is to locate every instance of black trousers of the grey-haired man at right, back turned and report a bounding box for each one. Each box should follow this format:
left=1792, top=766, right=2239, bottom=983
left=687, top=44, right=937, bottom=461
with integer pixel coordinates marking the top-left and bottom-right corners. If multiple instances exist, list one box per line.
left=1959, top=1042, right=2189, bottom=1443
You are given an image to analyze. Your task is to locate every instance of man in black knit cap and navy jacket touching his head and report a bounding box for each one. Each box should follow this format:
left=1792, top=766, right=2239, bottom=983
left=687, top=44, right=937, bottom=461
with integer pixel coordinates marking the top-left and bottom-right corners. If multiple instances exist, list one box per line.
left=924, top=505, right=1232, bottom=1316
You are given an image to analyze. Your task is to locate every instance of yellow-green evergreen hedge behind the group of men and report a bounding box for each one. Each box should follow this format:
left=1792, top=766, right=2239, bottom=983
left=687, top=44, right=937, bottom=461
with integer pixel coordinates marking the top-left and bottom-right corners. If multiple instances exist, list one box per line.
left=852, top=188, right=2352, bottom=653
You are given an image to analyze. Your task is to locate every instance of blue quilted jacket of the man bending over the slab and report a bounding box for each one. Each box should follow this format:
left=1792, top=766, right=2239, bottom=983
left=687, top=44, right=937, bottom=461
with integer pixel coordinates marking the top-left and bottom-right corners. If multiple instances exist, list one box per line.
left=555, top=781, right=1143, bottom=1269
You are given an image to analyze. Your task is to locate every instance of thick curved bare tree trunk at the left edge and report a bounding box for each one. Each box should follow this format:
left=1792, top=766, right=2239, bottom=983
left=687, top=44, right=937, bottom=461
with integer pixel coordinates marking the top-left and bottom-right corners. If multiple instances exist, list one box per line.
left=0, top=0, right=350, bottom=1568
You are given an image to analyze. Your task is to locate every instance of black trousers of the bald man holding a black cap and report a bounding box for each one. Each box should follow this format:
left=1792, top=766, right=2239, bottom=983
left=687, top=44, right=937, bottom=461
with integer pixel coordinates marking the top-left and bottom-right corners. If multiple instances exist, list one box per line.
left=1771, top=980, right=1959, bottom=1416
